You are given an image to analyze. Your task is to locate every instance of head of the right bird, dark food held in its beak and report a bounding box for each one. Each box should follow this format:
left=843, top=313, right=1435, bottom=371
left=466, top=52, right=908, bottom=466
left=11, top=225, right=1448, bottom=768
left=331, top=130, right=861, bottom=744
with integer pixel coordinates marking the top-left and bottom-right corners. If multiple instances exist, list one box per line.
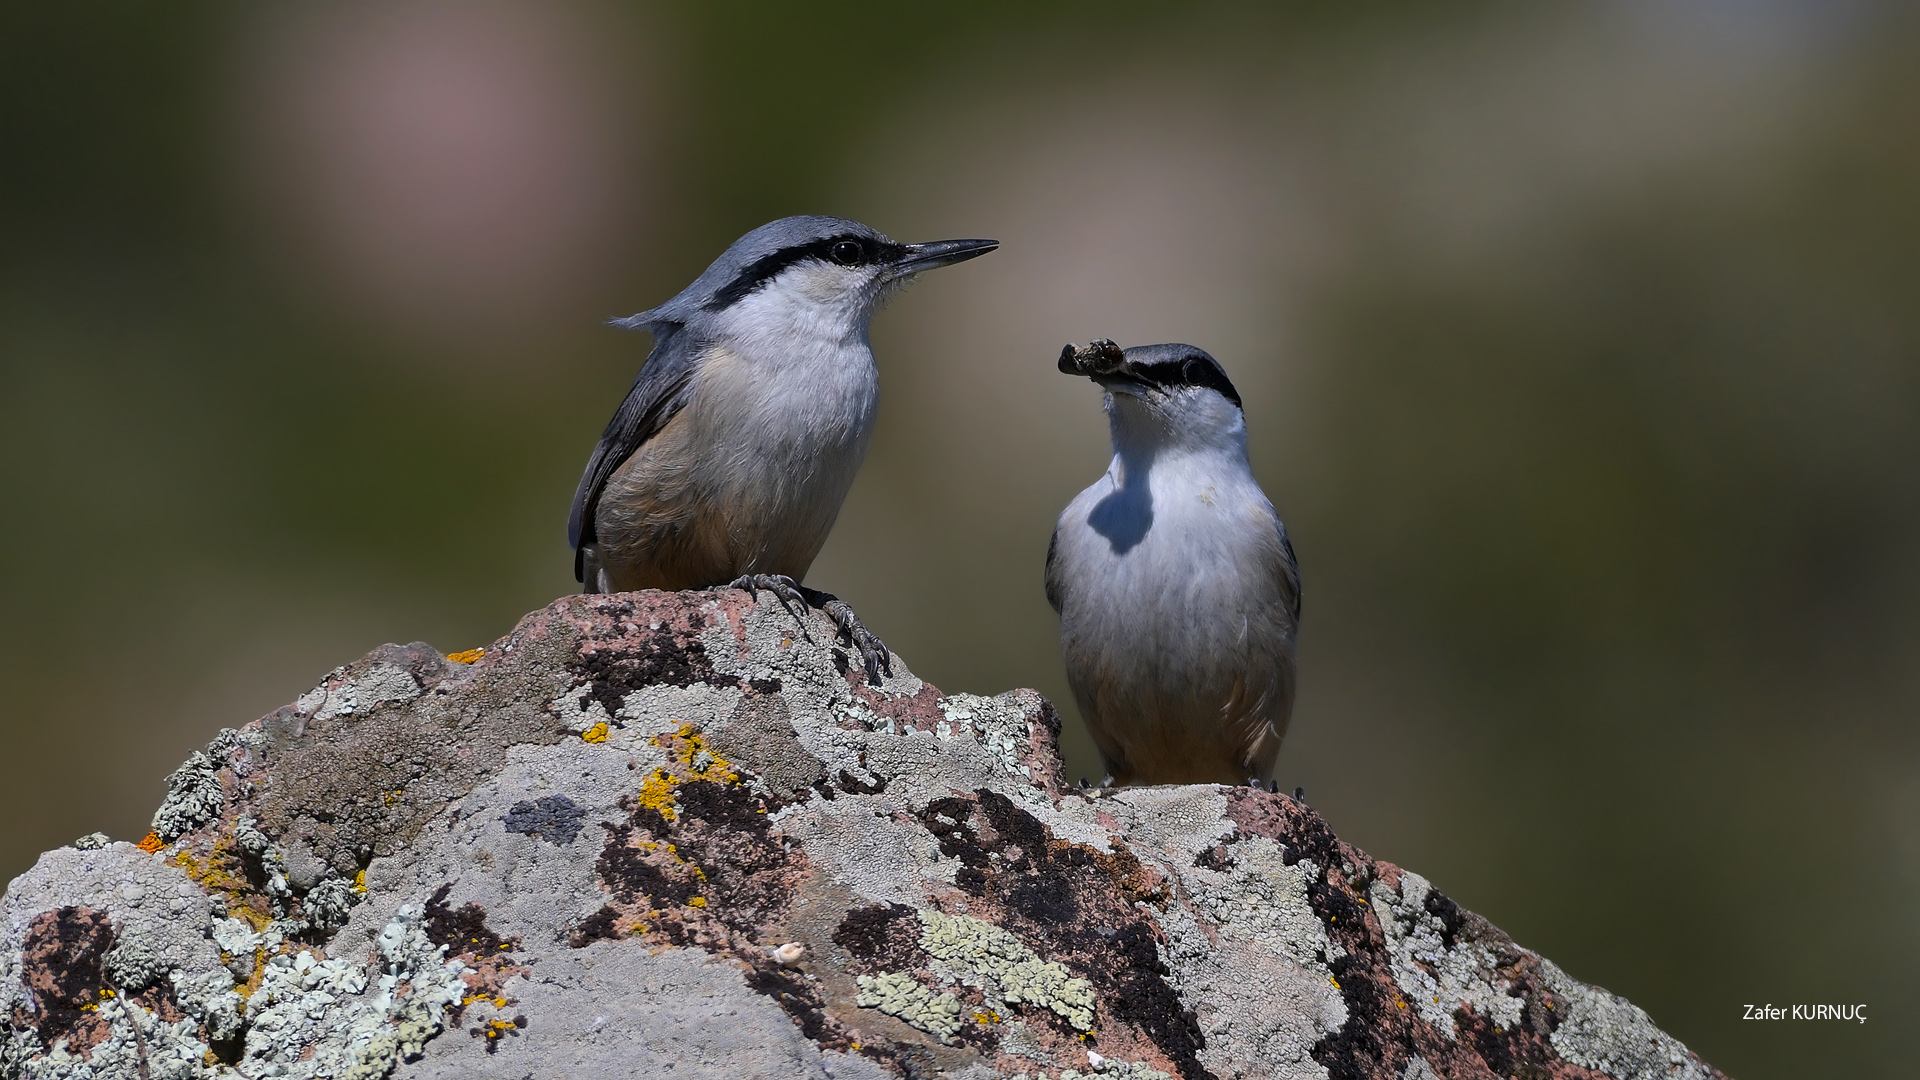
left=1060, top=338, right=1246, bottom=446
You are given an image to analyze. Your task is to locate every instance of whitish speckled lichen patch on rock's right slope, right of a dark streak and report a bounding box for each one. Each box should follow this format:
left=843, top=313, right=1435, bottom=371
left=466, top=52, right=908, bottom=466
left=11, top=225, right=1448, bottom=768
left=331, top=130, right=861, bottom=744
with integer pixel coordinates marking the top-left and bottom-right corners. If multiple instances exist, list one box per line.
left=1367, top=871, right=1520, bottom=1036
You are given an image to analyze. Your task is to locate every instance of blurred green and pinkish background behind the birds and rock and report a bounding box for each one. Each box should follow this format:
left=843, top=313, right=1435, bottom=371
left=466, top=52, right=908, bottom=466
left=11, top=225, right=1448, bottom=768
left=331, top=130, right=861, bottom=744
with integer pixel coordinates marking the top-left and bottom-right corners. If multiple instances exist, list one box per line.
left=0, top=0, right=1920, bottom=1078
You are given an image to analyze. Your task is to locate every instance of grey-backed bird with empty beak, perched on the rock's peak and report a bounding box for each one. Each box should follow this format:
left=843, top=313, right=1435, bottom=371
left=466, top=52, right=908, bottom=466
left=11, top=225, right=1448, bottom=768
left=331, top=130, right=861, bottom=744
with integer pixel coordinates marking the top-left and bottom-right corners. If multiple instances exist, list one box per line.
left=566, top=217, right=998, bottom=682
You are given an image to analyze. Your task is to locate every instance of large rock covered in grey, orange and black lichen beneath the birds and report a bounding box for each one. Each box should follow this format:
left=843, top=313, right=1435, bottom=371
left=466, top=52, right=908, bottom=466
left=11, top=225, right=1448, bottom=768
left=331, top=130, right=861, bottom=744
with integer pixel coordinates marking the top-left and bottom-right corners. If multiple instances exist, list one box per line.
left=0, top=592, right=1718, bottom=1080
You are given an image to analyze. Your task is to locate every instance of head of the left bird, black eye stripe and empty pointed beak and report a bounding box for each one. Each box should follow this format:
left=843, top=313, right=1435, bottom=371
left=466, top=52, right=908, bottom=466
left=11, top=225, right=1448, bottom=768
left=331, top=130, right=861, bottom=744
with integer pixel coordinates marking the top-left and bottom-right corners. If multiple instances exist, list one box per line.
left=614, top=217, right=1000, bottom=334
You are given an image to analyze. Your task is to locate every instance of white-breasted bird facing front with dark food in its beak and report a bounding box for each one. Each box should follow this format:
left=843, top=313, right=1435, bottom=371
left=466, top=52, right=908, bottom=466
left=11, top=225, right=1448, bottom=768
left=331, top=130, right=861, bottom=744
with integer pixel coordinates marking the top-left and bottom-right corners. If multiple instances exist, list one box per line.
left=1046, top=340, right=1300, bottom=786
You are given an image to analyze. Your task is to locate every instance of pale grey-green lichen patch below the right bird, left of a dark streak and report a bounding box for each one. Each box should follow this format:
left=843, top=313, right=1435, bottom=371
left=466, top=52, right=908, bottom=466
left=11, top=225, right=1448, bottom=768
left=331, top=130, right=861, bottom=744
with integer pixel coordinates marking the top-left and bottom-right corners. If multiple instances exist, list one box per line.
left=1188, top=836, right=1346, bottom=976
